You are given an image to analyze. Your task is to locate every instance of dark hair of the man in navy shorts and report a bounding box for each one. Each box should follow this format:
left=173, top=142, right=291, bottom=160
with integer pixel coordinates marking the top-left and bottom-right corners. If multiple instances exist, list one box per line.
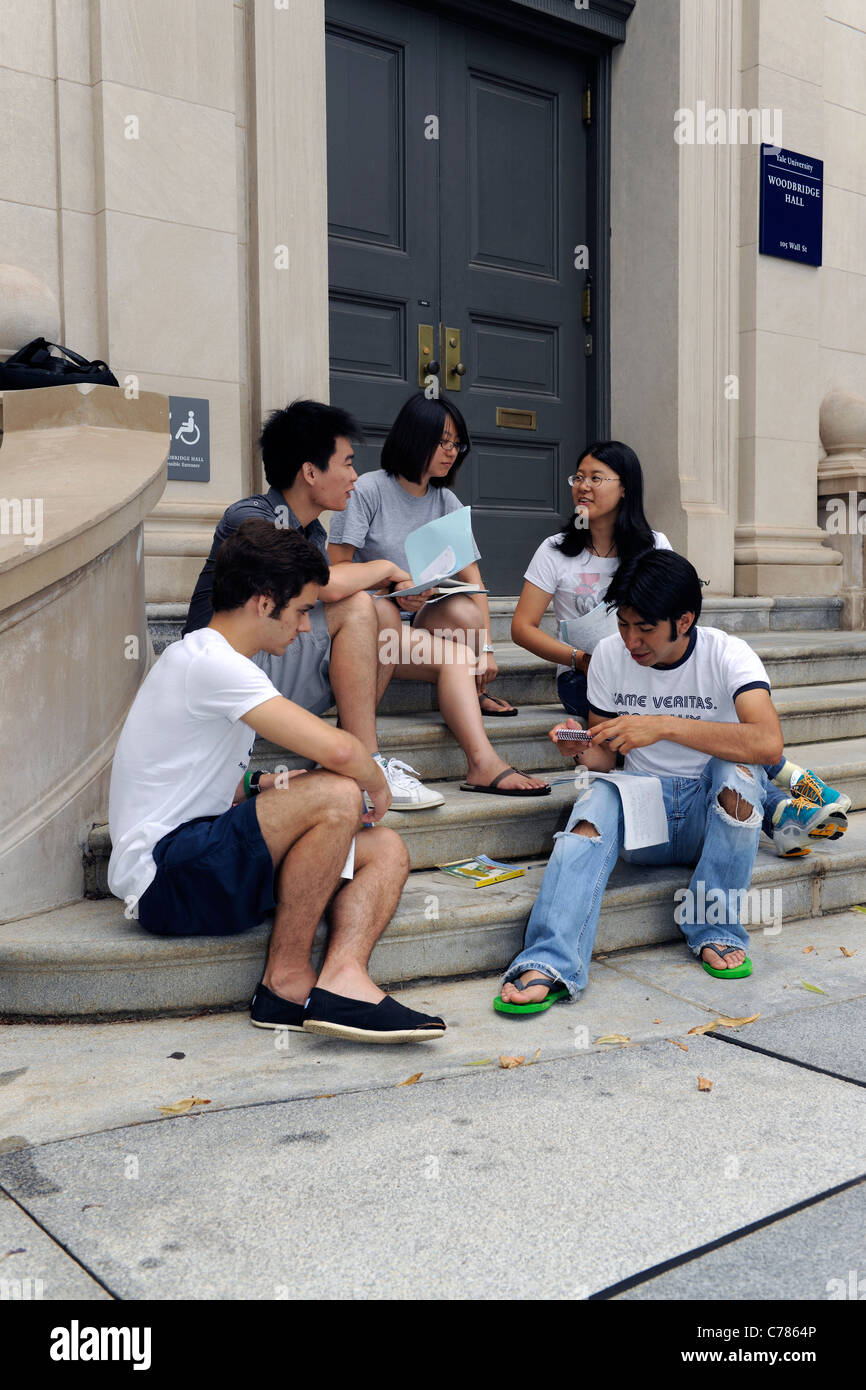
left=211, top=517, right=328, bottom=617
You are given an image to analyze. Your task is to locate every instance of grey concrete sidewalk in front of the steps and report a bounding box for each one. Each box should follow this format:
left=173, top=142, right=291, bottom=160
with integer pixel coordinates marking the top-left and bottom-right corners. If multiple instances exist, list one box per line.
left=0, top=912, right=866, bottom=1300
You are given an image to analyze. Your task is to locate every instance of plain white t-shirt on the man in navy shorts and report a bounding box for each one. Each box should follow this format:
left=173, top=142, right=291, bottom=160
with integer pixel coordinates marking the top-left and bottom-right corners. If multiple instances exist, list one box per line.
left=108, top=627, right=279, bottom=902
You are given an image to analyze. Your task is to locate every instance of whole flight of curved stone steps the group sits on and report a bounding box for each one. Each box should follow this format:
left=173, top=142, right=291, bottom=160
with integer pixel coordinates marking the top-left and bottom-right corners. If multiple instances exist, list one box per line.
left=0, top=599, right=866, bottom=1017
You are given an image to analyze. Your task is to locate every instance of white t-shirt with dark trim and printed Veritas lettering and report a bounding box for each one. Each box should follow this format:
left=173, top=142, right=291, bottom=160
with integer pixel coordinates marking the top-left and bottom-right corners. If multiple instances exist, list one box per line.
left=587, top=627, right=770, bottom=777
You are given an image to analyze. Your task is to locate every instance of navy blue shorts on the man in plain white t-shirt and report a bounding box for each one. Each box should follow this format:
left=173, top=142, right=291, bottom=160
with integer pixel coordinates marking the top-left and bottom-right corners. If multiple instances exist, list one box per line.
left=138, top=798, right=275, bottom=937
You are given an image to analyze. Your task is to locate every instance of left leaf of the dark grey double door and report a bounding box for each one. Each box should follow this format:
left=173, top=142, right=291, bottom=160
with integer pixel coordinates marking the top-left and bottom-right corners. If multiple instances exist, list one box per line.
left=327, top=0, right=439, bottom=471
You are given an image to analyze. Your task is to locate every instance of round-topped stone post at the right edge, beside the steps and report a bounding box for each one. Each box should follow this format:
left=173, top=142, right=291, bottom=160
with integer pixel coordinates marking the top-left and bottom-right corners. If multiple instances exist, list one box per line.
left=817, top=391, right=866, bottom=630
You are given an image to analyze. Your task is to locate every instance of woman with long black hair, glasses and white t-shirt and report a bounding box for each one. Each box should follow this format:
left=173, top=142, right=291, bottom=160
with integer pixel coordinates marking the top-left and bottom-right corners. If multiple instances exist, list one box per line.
left=512, top=439, right=671, bottom=723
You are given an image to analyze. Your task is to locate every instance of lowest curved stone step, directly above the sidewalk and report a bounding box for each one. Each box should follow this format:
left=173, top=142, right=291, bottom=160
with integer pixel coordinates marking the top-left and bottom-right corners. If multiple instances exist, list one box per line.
left=11, top=812, right=866, bottom=1019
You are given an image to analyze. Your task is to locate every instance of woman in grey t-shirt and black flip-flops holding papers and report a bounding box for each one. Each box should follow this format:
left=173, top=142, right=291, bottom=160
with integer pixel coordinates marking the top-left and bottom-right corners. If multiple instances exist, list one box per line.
left=328, top=392, right=550, bottom=796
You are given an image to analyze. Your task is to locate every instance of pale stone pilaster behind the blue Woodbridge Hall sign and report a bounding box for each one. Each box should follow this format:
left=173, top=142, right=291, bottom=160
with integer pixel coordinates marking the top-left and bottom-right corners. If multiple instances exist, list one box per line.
left=734, top=0, right=842, bottom=596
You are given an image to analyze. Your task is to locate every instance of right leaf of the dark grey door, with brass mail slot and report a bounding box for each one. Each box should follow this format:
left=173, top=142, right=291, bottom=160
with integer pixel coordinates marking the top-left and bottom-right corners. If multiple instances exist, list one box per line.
left=439, top=24, right=588, bottom=594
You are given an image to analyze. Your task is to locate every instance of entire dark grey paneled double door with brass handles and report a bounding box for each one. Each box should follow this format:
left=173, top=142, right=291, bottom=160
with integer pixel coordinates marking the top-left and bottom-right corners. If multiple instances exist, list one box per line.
left=327, top=0, right=589, bottom=594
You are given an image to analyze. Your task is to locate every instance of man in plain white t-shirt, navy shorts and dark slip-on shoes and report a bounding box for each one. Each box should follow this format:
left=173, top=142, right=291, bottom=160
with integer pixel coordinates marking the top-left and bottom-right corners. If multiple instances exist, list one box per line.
left=108, top=520, right=445, bottom=1043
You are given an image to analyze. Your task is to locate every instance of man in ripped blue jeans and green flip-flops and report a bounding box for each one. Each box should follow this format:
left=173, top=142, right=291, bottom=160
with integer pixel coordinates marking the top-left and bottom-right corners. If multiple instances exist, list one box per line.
left=495, top=550, right=783, bottom=1013
